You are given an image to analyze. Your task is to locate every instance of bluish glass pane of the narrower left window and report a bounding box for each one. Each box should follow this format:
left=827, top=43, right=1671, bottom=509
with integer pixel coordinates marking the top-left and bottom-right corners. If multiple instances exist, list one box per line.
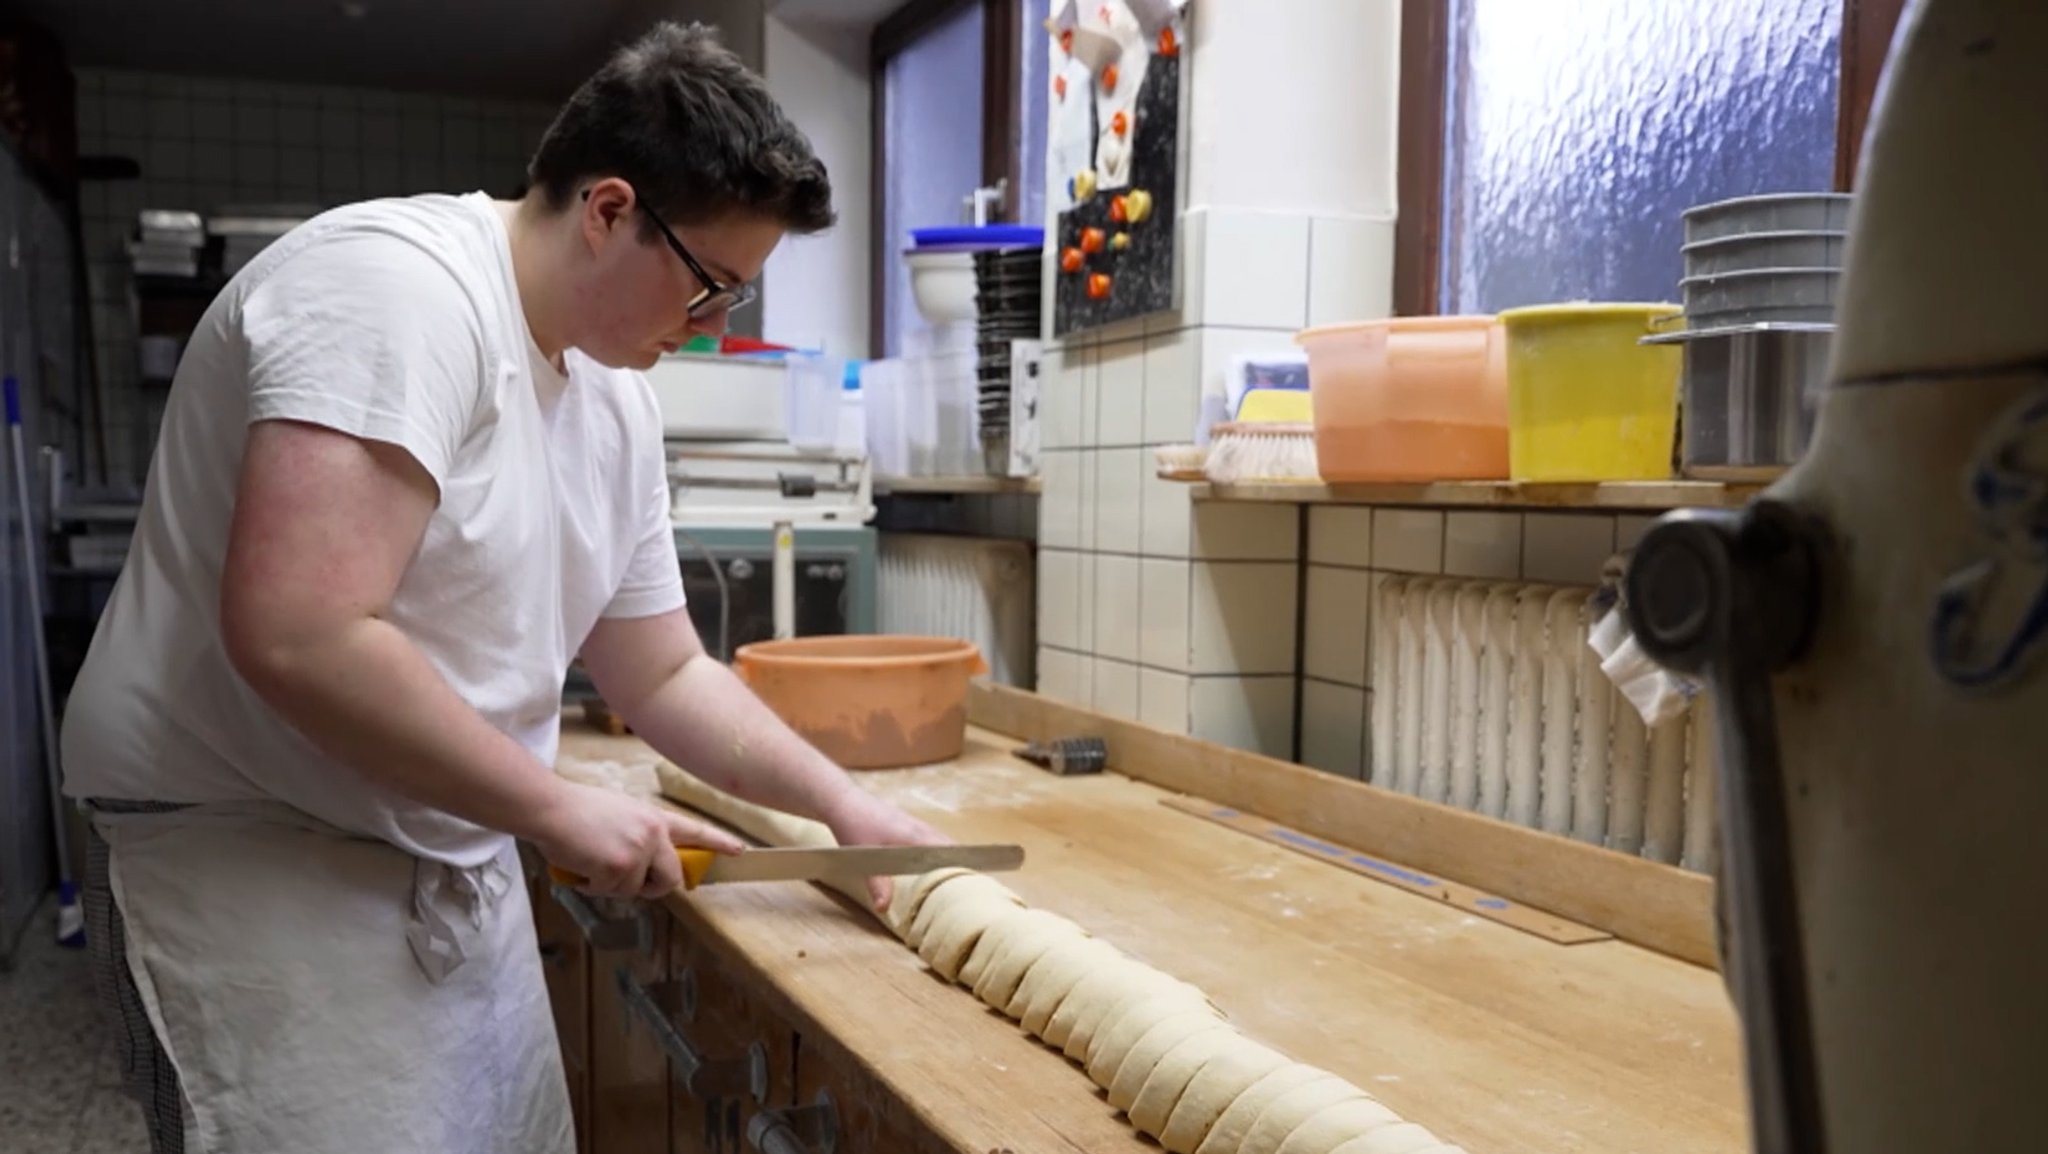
left=879, top=4, right=983, bottom=357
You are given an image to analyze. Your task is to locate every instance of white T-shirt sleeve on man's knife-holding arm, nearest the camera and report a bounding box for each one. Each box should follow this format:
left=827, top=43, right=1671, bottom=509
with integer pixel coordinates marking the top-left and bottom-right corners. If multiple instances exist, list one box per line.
left=240, top=232, right=492, bottom=488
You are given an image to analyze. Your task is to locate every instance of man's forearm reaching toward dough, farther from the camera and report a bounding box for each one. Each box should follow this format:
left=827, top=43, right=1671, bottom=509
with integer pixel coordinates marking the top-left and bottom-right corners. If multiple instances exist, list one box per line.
left=614, top=654, right=860, bottom=822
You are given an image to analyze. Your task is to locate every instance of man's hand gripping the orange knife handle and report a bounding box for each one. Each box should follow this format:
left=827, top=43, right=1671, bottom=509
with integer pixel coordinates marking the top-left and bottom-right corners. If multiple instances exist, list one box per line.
left=528, top=781, right=745, bottom=898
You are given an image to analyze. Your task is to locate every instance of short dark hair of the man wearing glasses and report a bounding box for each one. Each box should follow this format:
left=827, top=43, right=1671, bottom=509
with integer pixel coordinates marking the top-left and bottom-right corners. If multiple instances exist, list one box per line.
left=526, top=20, right=836, bottom=240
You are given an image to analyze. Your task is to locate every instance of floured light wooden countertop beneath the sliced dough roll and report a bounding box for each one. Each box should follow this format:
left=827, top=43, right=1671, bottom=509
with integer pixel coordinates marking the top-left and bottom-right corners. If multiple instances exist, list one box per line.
left=561, top=722, right=1747, bottom=1154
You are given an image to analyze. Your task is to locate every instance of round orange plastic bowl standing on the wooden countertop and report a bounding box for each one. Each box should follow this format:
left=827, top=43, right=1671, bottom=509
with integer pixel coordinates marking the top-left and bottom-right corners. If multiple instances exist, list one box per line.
left=733, top=633, right=989, bottom=769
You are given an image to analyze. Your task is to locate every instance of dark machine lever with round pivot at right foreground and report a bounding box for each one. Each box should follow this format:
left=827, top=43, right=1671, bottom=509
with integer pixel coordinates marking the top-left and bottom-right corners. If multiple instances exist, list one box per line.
left=1622, top=498, right=1827, bottom=1154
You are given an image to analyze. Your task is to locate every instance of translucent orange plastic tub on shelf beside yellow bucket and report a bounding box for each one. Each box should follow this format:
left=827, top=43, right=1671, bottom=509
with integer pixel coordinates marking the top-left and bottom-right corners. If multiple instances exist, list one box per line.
left=1294, top=316, right=1507, bottom=482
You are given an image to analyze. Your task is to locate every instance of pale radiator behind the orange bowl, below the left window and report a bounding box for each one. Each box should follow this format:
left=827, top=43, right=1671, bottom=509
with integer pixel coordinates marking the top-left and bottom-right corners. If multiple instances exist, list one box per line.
left=874, top=533, right=1038, bottom=689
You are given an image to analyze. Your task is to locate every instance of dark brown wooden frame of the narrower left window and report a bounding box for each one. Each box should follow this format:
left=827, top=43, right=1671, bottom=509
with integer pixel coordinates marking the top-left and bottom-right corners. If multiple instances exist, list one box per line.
left=868, top=0, right=1026, bottom=357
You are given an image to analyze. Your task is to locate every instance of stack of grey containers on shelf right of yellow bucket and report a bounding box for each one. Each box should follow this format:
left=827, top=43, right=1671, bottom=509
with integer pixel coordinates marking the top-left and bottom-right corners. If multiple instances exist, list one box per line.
left=1647, top=193, right=1849, bottom=480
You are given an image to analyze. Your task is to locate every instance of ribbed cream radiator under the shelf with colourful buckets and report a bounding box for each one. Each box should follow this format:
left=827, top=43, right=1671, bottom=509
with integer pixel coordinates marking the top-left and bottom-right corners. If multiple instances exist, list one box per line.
left=1366, top=576, right=1718, bottom=871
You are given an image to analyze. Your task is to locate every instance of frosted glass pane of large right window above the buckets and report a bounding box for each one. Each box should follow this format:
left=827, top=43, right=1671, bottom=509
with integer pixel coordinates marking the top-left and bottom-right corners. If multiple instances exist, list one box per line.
left=1440, top=0, right=1843, bottom=314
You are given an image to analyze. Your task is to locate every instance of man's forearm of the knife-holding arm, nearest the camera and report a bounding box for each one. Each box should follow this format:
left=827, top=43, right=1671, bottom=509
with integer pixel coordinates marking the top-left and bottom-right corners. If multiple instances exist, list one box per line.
left=233, top=617, right=561, bottom=838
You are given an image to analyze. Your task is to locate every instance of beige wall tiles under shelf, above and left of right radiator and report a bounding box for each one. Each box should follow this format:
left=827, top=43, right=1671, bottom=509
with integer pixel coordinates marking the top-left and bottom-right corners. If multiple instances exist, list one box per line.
left=1300, top=506, right=1655, bottom=777
